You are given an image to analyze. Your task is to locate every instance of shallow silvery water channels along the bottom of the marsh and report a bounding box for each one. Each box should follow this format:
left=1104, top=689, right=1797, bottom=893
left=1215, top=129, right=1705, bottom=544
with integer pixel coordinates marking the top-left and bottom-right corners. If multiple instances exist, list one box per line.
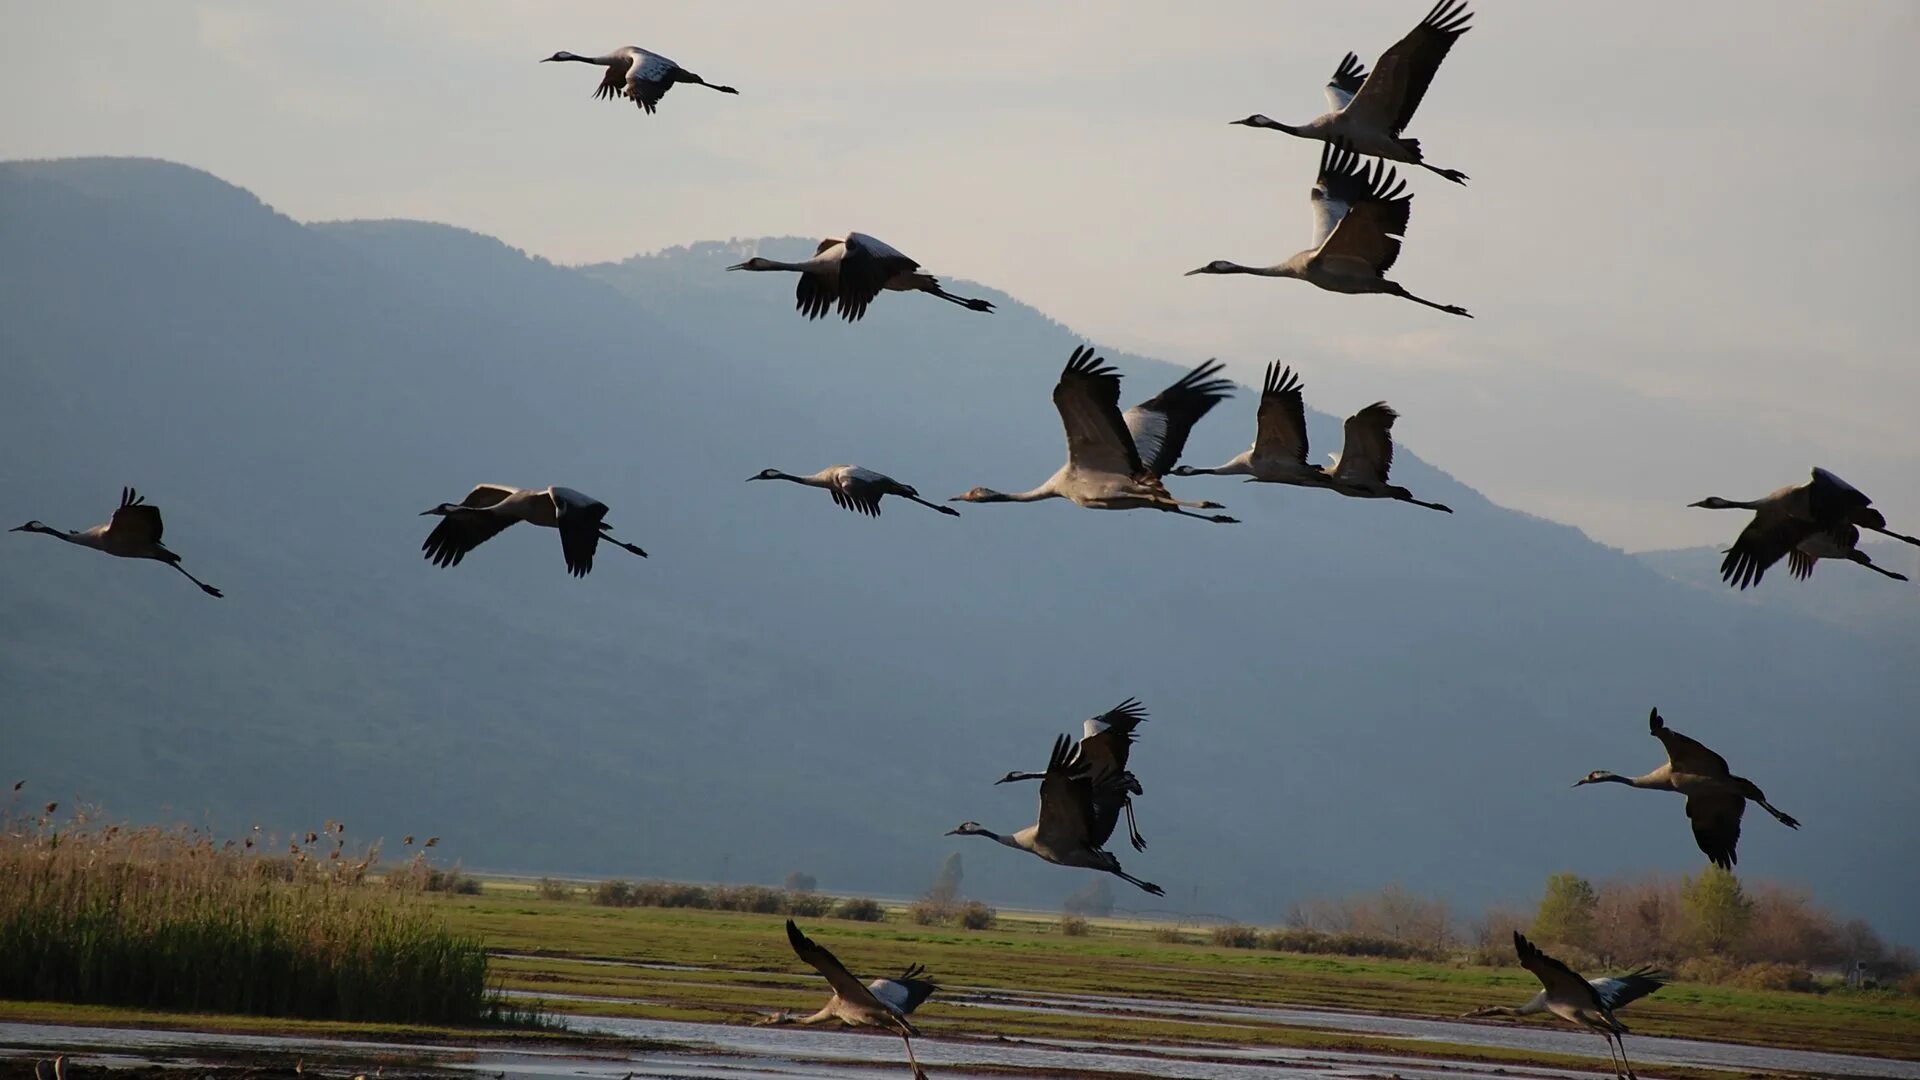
left=0, top=992, right=1920, bottom=1080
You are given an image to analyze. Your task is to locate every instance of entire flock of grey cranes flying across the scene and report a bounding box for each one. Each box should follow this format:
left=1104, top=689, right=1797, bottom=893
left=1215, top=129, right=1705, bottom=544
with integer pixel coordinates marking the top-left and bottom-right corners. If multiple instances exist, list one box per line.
left=13, top=0, right=1920, bottom=1076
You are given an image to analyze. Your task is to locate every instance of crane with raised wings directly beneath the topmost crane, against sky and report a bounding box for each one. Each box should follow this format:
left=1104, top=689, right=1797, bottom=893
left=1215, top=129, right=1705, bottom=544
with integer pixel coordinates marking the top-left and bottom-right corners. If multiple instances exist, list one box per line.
left=1187, top=144, right=1473, bottom=319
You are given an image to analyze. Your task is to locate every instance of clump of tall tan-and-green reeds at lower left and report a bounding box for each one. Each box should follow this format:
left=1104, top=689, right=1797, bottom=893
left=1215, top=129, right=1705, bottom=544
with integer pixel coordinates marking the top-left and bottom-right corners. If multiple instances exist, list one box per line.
left=0, top=815, right=530, bottom=1024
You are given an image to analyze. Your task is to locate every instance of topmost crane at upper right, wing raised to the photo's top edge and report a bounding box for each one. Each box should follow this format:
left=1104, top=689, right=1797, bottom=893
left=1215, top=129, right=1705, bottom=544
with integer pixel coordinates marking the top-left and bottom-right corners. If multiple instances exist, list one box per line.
left=1233, top=0, right=1473, bottom=184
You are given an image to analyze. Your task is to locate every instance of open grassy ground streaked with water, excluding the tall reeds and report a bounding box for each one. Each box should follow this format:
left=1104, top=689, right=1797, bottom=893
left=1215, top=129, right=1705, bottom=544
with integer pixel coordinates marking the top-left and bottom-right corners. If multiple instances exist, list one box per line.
left=15, top=884, right=1920, bottom=1078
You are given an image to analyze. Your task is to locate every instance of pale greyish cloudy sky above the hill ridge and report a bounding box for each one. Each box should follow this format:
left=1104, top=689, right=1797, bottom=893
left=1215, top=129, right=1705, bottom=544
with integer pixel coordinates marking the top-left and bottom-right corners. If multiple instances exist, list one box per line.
left=0, top=0, right=1920, bottom=550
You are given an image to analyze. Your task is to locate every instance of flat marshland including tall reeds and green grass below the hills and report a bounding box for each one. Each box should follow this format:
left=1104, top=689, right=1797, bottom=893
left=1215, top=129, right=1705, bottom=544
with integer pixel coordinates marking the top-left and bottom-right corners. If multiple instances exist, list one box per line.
left=0, top=826, right=1920, bottom=1078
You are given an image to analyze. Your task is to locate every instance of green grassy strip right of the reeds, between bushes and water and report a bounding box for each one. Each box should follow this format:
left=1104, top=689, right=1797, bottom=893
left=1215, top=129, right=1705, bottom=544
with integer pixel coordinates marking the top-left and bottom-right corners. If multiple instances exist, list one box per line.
left=436, top=892, right=1920, bottom=1059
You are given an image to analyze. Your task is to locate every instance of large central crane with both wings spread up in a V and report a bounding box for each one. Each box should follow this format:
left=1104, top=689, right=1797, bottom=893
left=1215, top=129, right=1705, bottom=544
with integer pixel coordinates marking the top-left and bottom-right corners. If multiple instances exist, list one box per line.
left=950, top=346, right=1235, bottom=525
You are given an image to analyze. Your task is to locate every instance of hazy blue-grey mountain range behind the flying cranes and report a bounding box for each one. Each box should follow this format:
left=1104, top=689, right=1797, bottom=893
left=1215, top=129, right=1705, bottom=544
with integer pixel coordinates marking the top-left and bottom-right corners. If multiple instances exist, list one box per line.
left=0, top=160, right=1920, bottom=940
